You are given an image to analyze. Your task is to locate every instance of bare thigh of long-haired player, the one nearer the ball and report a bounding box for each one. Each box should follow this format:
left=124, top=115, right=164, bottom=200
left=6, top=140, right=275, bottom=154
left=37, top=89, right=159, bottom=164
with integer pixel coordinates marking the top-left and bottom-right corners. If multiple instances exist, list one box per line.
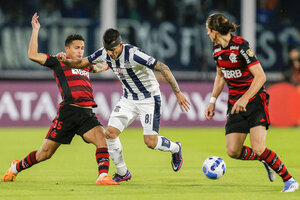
left=226, top=133, right=247, bottom=158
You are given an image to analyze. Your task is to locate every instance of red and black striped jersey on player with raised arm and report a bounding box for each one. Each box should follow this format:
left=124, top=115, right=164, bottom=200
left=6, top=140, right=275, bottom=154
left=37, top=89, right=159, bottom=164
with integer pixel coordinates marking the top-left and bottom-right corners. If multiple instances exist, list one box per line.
left=44, top=54, right=97, bottom=107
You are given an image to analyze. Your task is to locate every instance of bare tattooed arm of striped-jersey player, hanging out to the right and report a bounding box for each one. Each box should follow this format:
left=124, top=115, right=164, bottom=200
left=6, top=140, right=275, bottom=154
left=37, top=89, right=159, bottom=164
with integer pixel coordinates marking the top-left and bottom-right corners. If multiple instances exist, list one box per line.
left=153, top=61, right=191, bottom=112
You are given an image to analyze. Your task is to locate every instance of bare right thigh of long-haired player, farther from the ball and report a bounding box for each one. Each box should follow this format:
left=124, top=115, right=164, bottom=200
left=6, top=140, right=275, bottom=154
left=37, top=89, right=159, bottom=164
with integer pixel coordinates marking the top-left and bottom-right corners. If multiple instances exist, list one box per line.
left=250, top=125, right=267, bottom=156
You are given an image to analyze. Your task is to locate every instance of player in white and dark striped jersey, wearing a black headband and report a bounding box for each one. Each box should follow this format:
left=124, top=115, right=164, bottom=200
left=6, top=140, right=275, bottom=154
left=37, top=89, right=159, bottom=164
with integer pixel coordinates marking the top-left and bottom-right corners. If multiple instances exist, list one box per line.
left=57, top=29, right=190, bottom=182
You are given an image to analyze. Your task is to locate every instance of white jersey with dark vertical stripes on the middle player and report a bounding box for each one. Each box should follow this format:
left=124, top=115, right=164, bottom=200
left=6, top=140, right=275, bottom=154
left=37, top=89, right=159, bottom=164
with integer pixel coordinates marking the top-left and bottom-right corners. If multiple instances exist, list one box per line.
left=88, top=44, right=160, bottom=100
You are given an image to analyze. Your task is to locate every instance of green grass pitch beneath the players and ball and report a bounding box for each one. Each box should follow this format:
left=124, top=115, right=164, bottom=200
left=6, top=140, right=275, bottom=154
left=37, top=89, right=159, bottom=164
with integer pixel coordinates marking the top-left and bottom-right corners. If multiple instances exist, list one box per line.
left=0, top=128, right=300, bottom=200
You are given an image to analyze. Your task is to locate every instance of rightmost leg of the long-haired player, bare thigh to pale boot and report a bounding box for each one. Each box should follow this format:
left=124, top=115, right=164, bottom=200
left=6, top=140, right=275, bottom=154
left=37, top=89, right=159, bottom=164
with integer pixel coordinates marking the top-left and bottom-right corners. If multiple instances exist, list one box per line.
left=250, top=126, right=299, bottom=192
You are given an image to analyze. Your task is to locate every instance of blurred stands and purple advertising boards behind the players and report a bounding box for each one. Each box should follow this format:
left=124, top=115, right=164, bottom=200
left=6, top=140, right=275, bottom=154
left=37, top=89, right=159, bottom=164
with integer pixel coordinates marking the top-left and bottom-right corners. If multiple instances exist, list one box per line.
left=0, top=0, right=300, bottom=126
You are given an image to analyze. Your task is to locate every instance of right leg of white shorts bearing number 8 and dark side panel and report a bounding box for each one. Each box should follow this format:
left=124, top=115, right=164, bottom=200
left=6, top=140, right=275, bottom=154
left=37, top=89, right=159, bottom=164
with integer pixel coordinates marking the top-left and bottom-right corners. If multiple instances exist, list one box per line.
left=138, top=95, right=162, bottom=135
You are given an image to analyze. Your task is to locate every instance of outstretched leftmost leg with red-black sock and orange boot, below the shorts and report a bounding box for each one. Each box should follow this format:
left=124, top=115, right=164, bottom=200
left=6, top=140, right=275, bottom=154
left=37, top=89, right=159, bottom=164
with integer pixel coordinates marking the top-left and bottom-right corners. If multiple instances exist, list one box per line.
left=3, top=139, right=60, bottom=182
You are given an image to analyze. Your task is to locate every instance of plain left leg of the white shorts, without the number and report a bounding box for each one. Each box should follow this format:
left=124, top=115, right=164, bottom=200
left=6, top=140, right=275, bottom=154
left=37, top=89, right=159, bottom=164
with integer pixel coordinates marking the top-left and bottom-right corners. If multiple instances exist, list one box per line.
left=108, top=97, right=138, bottom=132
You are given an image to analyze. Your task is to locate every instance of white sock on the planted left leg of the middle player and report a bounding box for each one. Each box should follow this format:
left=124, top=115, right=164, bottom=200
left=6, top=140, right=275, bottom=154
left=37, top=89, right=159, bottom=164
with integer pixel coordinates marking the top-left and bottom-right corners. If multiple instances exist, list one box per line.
left=106, top=137, right=127, bottom=176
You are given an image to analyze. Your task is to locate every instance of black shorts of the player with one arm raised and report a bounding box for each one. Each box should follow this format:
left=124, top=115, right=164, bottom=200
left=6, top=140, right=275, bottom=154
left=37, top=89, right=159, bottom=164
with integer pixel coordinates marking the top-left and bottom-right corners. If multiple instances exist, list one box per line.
left=46, top=105, right=102, bottom=144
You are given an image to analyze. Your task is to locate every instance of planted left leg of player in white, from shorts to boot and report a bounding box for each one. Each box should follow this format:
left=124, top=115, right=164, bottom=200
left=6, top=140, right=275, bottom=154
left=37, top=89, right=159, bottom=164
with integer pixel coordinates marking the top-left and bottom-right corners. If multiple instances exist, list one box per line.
left=105, top=98, right=137, bottom=182
